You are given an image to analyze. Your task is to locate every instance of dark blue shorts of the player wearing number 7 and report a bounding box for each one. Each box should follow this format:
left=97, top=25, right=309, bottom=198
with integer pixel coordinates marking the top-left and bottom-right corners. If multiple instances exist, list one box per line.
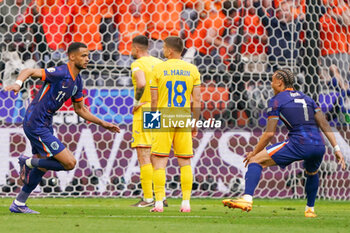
left=266, top=140, right=326, bottom=172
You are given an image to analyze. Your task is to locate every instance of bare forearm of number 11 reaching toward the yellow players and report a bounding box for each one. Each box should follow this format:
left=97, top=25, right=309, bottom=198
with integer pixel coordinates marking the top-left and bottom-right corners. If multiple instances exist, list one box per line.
left=73, top=101, right=120, bottom=133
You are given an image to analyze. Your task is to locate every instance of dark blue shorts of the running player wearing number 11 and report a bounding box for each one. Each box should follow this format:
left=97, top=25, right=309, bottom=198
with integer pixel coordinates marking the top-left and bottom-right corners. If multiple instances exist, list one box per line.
left=23, top=125, right=66, bottom=157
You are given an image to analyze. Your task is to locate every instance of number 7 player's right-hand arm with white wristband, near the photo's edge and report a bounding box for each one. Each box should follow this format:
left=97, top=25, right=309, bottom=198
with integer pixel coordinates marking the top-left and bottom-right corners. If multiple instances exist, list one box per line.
left=315, top=111, right=346, bottom=170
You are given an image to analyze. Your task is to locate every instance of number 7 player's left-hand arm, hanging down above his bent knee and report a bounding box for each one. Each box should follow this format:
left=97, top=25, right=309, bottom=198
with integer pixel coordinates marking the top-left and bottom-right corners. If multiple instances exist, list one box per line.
left=243, top=118, right=278, bottom=167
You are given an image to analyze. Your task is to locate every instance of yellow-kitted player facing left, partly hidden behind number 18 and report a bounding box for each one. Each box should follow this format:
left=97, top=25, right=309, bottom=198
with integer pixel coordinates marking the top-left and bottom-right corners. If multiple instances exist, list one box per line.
left=131, top=35, right=163, bottom=207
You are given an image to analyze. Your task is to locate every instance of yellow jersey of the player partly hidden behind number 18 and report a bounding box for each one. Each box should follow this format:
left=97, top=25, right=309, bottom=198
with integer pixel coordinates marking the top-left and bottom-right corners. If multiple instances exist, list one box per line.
left=131, top=56, right=163, bottom=103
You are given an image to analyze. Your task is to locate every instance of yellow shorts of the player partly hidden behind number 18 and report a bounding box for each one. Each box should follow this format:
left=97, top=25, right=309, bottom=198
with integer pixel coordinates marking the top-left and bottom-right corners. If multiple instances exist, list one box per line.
left=131, top=104, right=152, bottom=148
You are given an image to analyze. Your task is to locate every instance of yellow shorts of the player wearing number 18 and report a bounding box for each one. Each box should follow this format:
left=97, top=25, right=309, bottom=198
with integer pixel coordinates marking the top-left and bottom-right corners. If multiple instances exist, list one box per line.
left=151, top=128, right=193, bottom=158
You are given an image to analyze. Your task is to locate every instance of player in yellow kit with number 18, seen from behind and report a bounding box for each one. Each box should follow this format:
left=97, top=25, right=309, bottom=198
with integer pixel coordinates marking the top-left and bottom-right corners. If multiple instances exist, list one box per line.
left=151, top=36, right=201, bottom=212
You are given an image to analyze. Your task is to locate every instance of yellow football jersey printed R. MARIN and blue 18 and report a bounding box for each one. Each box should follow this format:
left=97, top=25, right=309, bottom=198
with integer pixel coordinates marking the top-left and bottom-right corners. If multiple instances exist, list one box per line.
left=151, top=59, right=201, bottom=109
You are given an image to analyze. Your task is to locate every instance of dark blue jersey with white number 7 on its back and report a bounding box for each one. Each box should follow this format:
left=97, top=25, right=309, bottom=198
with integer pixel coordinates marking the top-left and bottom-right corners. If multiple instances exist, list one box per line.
left=268, top=88, right=324, bottom=145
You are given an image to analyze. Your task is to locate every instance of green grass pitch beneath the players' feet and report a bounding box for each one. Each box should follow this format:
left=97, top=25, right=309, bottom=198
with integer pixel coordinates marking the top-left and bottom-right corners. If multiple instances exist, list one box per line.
left=0, top=198, right=350, bottom=233
